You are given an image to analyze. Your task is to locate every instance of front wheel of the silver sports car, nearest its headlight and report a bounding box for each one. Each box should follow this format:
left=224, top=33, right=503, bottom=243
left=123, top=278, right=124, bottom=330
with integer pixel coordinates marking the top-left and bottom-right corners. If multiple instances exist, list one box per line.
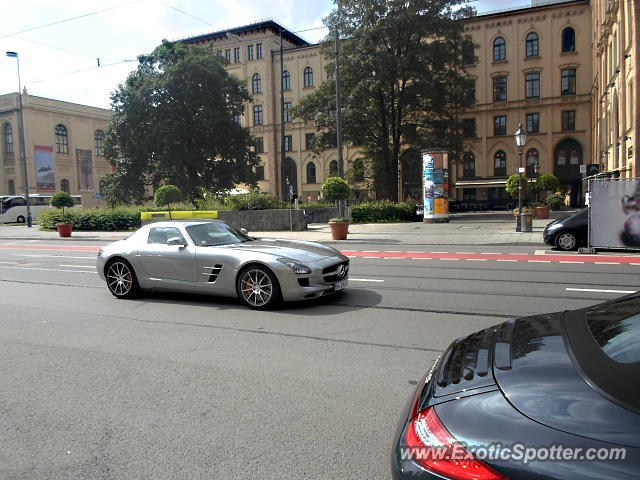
left=236, top=265, right=280, bottom=310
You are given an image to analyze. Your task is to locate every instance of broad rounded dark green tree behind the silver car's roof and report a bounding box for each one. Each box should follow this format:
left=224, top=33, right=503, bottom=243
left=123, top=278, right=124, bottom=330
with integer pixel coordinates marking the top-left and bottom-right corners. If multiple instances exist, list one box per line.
left=105, top=40, right=259, bottom=204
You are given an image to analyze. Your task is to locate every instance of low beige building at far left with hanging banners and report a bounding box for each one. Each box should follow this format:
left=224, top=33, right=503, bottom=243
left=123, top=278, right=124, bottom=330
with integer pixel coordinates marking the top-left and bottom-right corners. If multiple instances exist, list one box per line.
left=0, top=93, right=111, bottom=207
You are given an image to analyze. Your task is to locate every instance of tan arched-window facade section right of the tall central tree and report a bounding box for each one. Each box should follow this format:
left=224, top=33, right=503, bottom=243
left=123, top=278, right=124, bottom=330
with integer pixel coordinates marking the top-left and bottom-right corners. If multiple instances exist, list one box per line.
left=458, top=0, right=593, bottom=206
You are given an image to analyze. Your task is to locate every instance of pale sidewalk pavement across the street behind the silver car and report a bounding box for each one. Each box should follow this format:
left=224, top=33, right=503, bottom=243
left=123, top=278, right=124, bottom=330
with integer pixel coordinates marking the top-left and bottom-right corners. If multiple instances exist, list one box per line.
left=0, top=214, right=551, bottom=248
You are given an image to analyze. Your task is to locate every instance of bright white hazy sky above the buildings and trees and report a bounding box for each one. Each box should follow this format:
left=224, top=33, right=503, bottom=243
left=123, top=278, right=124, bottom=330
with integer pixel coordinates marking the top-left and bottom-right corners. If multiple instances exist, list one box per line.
left=0, top=0, right=528, bottom=108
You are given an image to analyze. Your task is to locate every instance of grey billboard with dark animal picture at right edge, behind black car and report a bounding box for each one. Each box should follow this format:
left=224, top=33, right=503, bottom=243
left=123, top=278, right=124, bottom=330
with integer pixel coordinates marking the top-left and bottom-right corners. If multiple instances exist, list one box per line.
left=589, top=178, right=640, bottom=249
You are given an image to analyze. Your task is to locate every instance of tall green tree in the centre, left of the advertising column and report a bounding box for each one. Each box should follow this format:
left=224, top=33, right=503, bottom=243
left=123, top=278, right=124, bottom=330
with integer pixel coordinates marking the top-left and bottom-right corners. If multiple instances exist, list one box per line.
left=294, top=0, right=473, bottom=200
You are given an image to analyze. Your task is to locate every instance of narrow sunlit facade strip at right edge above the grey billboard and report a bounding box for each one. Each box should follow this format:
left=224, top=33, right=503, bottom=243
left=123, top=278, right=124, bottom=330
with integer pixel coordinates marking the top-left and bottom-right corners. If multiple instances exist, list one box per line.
left=591, top=0, right=640, bottom=178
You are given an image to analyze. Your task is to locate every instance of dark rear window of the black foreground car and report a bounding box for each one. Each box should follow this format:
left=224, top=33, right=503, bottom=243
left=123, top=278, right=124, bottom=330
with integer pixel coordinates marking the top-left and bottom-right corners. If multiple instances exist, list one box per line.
left=586, top=297, right=640, bottom=363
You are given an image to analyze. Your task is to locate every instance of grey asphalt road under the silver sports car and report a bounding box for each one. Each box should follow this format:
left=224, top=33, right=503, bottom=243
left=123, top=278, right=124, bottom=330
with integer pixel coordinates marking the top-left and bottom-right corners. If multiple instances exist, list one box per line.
left=0, top=241, right=640, bottom=480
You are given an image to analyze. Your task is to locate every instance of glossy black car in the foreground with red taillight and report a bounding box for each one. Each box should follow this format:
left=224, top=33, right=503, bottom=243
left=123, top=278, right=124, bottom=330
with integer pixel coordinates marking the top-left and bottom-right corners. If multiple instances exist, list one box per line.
left=391, top=294, right=640, bottom=480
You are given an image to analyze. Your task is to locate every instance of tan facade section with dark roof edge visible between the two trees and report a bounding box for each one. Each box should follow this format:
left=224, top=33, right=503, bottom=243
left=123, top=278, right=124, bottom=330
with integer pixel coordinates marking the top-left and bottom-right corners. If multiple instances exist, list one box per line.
left=183, top=21, right=360, bottom=201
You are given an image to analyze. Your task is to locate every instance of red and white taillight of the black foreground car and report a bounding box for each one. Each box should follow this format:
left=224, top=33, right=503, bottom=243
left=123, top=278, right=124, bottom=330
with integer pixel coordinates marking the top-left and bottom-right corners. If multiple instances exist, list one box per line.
left=406, top=407, right=508, bottom=480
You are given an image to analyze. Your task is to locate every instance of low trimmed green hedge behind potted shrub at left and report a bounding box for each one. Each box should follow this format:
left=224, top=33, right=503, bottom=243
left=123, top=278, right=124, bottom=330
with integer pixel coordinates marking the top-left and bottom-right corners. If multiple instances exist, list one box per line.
left=38, top=207, right=143, bottom=232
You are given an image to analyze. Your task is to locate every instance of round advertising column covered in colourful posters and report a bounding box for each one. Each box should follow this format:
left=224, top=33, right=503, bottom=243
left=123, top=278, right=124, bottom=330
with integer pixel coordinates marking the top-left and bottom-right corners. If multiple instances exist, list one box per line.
left=422, top=153, right=449, bottom=223
